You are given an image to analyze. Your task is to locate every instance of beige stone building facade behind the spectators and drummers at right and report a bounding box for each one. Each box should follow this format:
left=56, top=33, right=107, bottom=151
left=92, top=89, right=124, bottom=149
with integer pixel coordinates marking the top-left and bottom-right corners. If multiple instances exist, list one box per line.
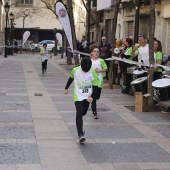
left=90, top=0, right=170, bottom=56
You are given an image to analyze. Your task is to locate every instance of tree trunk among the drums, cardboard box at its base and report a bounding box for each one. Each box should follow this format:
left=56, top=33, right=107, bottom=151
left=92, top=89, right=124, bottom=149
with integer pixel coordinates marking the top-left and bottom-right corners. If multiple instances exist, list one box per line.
left=148, top=0, right=155, bottom=110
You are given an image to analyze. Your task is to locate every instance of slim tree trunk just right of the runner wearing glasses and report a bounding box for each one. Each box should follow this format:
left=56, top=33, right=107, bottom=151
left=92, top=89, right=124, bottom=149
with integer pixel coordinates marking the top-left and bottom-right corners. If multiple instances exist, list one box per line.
left=108, top=0, right=121, bottom=89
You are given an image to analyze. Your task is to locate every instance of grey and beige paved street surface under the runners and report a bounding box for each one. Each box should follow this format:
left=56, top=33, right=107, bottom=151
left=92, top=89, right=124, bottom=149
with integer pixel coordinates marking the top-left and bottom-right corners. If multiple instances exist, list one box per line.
left=0, top=54, right=170, bottom=170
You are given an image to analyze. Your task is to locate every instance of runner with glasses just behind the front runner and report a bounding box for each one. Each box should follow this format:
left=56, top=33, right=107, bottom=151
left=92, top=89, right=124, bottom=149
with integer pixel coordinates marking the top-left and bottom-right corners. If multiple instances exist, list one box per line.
left=90, top=46, right=107, bottom=119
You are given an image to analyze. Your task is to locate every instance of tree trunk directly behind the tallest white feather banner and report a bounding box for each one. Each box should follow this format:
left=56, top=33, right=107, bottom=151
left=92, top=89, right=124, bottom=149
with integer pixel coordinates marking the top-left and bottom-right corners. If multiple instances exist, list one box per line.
left=67, top=0, right=79, bottom=65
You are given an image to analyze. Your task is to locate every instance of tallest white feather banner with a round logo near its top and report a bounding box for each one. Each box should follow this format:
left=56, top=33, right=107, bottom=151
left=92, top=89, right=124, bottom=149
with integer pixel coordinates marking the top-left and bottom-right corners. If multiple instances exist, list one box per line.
left=55, top=2, right=73, bottom=52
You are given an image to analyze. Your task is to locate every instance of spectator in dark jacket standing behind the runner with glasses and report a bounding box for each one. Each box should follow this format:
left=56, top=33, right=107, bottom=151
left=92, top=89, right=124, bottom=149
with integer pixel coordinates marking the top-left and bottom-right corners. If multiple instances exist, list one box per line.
left=100, top=37, right=112, bottom=80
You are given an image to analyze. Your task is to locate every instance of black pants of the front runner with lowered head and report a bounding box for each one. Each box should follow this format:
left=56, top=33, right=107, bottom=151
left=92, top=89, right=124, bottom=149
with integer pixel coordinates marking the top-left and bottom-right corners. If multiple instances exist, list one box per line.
left=75, top=100, right=89, bottom=135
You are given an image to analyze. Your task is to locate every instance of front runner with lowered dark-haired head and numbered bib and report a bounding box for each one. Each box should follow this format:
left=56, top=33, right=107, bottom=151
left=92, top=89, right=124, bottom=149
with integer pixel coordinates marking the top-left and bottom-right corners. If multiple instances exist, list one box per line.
left=65, top=57, right=99, bottom=142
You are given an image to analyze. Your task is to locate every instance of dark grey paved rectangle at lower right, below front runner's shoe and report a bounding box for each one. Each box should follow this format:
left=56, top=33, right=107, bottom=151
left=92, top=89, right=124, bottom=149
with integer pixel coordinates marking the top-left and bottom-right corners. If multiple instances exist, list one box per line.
left=79, top=143, right=170, bottom=163
